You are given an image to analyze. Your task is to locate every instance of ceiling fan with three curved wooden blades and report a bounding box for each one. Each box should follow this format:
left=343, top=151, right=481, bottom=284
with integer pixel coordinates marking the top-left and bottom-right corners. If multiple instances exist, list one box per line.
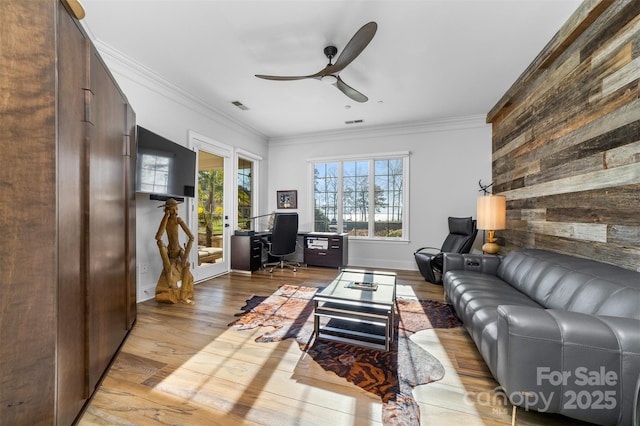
left=256, top=22, right=378, bottom=102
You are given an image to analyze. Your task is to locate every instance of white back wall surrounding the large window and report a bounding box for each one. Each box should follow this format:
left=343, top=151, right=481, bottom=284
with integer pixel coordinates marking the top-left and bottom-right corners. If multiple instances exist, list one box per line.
left=267, top=117, right=491, bottom=269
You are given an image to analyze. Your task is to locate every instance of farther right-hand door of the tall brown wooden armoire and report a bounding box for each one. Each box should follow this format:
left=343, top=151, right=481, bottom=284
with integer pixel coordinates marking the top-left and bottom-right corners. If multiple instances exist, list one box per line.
left=85, top=47, right=128, bottom=390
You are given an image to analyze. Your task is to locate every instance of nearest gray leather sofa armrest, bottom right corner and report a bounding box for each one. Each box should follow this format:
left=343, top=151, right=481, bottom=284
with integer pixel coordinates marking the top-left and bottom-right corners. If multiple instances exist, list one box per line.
left=497, top=305, right=640, bottom=425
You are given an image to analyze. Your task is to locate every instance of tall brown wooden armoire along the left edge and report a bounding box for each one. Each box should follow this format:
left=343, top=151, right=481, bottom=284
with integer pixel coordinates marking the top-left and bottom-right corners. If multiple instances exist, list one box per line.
left=0, top=0, right=136, bottom=425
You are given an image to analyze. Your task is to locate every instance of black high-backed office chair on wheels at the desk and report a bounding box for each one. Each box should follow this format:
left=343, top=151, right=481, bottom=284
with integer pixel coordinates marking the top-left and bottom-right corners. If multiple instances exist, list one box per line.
left=263, top=213, right=300, bottom=272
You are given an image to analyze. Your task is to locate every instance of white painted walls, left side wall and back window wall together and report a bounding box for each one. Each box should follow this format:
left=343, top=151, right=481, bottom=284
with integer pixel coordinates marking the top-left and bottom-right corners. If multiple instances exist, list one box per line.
left=91, top=43, right=491, bottom=301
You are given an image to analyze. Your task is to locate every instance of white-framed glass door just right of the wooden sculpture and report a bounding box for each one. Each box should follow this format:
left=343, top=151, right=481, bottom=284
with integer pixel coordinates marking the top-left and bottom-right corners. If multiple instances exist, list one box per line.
left=190, top=133, right=234, bottom=282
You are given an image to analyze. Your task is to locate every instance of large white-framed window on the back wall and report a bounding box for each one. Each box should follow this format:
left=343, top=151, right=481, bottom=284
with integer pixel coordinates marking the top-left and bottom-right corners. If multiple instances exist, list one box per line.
left=312, top=153, right=409, bottom=240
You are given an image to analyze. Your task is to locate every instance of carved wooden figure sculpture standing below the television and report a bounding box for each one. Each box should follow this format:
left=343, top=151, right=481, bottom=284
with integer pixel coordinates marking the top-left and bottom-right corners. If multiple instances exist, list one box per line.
left=156, top=198, right=194, bottom=304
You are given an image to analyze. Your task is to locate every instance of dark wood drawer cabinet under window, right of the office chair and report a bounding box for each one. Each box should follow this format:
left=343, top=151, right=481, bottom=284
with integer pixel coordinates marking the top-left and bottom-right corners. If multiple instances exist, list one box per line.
left=304, top=232, right=349, bottom=268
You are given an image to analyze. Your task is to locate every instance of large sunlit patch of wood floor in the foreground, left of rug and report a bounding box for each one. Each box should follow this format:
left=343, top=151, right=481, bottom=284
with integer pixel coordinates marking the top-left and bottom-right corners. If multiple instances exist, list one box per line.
left=154, top=320, right=381, bottom=424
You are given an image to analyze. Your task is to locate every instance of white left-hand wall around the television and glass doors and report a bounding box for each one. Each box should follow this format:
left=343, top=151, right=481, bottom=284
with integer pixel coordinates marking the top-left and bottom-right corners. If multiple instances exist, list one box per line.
left=96, top=43, right=268, bottom=301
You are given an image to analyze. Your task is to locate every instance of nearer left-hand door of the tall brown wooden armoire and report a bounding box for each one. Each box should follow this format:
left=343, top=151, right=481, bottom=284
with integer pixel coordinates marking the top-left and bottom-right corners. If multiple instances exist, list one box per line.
left=56, top=3, right=89, bottom=425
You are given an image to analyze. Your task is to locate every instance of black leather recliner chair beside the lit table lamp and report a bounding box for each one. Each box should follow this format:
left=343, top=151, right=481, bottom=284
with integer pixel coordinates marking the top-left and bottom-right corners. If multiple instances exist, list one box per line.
left=413, top=217, right=478, bottom=284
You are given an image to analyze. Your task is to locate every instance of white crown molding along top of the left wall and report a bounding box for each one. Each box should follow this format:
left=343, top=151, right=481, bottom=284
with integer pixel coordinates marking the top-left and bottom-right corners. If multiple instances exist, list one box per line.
left=93, top=39, right=268, bottom=142
